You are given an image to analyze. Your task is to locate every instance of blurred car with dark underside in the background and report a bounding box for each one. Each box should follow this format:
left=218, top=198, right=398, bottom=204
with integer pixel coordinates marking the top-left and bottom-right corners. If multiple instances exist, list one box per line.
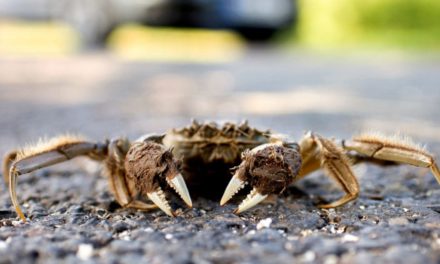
left=0, top=0, right=297, bottom=45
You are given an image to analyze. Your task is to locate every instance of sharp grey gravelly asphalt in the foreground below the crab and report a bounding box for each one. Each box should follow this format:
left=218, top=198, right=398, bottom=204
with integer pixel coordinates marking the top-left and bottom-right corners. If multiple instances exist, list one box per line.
left=0, top=160, right=440, bottom=263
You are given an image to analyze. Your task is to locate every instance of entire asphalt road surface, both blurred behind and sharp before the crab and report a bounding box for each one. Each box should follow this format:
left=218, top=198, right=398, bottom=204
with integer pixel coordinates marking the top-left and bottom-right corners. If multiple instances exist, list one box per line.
left=0, top=49, right=440, bottom=263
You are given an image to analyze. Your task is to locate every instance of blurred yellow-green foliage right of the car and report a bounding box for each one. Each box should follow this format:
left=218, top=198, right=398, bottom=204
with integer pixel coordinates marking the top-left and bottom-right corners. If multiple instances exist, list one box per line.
left=295, top=0, right=440, bottom=50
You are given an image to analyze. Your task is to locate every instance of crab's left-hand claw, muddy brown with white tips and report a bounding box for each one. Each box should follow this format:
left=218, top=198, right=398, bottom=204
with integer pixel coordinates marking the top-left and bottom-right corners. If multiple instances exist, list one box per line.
left=125, top=141, right=192, bottom=216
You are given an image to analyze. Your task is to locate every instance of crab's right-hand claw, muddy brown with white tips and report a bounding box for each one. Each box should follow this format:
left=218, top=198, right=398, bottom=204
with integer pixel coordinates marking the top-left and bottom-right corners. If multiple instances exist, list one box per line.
left=220, top=142, right=301, bottom=214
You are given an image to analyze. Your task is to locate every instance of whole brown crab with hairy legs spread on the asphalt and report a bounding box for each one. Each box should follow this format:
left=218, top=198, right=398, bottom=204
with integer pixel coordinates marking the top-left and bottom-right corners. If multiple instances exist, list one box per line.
left=3, top=121, right=440, bottom=221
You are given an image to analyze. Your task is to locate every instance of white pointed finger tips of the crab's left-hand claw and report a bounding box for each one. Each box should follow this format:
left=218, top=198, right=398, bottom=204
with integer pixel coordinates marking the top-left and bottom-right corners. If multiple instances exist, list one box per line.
left=147, top=174, right=192, bottom=216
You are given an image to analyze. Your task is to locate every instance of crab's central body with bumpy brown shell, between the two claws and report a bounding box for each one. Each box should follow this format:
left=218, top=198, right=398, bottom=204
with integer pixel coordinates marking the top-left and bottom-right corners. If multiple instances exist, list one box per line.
left=162, top=121, right=273, bottom=199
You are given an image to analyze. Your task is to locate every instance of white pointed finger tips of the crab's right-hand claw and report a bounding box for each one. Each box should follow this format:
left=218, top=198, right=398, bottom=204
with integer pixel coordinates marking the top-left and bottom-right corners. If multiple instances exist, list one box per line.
left=220, top=175, right=268, bottom=214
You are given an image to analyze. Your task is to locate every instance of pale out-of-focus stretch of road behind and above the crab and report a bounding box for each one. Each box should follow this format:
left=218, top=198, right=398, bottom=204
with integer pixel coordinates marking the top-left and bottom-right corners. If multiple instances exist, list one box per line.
left=0, top=48, right=440, bottom=153
